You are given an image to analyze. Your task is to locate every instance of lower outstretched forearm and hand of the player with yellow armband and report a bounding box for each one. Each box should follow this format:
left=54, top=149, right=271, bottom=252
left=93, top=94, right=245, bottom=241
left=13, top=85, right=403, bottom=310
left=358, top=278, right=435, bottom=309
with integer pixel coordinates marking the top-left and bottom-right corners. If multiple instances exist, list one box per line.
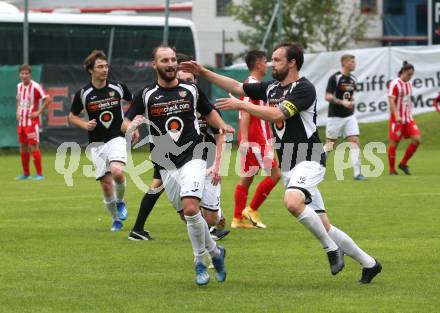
left=215, top=95, right=289, bottom=122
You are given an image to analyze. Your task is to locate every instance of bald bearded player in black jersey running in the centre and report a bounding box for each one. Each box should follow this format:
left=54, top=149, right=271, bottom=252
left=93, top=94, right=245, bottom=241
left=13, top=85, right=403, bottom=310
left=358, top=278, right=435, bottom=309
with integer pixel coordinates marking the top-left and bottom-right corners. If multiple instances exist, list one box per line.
left=122, top=45, right=234, bottom=286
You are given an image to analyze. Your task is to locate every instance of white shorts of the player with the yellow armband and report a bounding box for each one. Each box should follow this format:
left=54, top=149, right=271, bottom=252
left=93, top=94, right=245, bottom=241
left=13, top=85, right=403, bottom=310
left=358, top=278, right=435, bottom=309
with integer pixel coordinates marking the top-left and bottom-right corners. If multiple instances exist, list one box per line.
left=282, top=161, right=325, bottom=214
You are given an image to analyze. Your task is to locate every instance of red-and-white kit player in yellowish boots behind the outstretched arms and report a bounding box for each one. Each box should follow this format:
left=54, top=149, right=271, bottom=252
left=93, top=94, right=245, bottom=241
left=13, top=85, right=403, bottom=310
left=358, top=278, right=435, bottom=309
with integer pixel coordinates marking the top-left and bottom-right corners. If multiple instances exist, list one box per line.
left=231, top=50, right=281, bottom=228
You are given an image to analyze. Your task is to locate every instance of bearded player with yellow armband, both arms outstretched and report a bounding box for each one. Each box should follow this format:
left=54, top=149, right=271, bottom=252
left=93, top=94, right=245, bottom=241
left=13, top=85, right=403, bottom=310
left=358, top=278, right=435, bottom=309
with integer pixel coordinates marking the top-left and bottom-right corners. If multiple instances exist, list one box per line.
left=180, top=43, right=382, bottom=283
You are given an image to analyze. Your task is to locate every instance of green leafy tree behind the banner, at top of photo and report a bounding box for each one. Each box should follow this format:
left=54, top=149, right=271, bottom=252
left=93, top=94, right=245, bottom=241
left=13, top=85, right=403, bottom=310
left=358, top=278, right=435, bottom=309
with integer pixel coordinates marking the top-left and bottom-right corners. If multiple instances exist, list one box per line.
left=230, top=0, right=367, bottom=51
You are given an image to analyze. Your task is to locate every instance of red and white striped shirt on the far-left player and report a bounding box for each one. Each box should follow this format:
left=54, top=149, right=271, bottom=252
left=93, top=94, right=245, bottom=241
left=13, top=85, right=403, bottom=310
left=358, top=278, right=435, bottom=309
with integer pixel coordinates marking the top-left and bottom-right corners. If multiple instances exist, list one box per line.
left=17, top=80, right=48, bottom=127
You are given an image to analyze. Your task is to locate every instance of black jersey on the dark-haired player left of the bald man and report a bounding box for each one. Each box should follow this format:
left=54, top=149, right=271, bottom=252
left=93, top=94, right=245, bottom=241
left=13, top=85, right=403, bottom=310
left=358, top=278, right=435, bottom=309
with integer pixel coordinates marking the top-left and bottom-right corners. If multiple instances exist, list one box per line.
left=70, top=80, right=132, bottom=142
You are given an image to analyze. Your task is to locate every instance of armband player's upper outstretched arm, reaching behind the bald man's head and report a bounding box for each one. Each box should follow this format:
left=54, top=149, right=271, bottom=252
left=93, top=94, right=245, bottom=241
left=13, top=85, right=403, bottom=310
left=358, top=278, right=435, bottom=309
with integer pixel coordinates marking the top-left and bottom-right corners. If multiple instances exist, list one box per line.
left=179, top=61, right=245, bottom=96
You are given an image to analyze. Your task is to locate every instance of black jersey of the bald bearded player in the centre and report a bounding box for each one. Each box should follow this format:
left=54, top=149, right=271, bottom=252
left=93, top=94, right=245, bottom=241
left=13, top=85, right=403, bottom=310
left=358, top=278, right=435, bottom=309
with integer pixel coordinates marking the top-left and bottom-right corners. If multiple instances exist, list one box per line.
left=126, top=81, right=213, bottom=168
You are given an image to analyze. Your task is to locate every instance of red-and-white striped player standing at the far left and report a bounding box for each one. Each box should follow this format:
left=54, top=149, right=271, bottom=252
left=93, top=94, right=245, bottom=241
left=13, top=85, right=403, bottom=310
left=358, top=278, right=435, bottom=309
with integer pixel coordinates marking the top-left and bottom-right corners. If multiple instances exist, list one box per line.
left=17, top=64, right=50, bottom=180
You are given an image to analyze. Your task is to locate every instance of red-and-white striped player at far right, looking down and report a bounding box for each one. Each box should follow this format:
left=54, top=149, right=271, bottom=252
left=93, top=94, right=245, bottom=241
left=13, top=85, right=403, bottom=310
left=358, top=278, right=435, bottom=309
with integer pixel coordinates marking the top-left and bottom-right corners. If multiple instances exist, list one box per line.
left=388, top=61, right=420, bottom=175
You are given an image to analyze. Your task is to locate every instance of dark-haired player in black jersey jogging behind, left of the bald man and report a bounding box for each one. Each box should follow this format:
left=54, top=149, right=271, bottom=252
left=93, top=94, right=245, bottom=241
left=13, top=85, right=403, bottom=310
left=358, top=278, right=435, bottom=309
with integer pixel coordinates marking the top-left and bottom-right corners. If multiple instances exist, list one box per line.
left=69, top=50, right=132, bottom=231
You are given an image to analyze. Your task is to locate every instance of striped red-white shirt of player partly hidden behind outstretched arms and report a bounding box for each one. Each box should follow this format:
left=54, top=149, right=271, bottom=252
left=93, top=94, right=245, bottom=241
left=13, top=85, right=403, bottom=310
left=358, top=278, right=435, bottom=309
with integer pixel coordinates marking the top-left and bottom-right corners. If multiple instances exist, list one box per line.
left=238, top=76, right=271, bottom=145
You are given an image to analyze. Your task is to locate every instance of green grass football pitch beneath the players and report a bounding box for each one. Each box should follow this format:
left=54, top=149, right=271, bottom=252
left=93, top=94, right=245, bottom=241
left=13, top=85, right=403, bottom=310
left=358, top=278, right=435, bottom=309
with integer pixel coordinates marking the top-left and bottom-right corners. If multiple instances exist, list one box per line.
left=0, top=114, right=440, bottom=313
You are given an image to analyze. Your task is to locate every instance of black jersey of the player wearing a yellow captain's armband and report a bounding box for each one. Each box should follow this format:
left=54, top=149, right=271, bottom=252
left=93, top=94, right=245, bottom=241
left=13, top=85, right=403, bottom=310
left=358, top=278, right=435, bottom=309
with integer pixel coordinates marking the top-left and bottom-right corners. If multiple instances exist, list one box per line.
left=243, top=77, right=325, bottom=172
